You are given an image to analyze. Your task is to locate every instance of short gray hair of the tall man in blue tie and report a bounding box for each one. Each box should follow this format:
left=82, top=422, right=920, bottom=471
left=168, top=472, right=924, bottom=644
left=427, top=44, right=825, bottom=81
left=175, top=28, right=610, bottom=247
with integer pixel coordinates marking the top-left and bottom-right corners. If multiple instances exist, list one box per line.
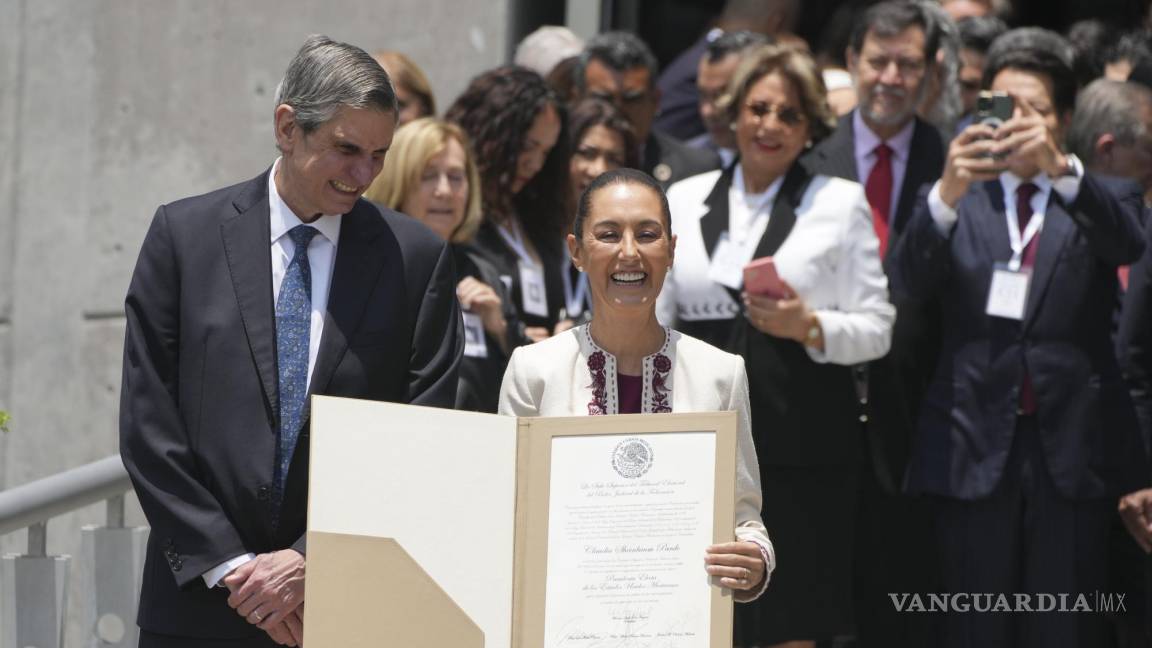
left=276, top=35, right=399, bottom=133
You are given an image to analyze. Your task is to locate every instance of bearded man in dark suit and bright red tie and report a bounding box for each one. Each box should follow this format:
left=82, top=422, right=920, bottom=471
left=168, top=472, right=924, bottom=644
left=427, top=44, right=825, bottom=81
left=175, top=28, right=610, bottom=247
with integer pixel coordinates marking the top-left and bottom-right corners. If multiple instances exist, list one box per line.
left=804, top=2, right=945, bottom=648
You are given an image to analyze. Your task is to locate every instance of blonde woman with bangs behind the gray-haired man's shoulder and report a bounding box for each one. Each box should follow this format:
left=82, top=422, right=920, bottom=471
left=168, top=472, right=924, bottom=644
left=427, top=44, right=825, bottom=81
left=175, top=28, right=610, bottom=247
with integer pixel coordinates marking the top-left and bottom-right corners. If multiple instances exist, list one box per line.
left=364, top=118, right=528, bottom=412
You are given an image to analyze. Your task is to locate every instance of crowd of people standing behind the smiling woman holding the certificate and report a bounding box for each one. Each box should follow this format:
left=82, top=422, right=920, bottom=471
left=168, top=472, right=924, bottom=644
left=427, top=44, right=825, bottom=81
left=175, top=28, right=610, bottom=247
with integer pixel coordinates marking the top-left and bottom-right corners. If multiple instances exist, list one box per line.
left=367, top=1, right=1152, bottom=646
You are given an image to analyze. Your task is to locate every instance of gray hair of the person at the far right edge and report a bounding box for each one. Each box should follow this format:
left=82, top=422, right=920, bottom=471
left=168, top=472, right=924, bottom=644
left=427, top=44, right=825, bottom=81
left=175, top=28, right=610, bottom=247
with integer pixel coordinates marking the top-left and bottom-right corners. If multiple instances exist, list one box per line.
left=1067, top=78, right=1152, bottom=167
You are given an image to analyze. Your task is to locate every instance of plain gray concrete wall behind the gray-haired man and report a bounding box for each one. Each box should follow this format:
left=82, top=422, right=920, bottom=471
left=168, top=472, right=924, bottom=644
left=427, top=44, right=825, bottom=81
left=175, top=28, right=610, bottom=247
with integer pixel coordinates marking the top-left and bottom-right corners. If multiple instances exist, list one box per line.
left=0, top=0, right=509, bottom=645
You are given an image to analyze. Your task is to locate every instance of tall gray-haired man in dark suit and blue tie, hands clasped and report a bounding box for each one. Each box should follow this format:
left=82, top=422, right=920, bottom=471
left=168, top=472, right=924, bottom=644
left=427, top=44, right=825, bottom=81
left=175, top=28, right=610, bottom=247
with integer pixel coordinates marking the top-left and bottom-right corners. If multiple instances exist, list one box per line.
left=120, top=36, right=463, bottom=648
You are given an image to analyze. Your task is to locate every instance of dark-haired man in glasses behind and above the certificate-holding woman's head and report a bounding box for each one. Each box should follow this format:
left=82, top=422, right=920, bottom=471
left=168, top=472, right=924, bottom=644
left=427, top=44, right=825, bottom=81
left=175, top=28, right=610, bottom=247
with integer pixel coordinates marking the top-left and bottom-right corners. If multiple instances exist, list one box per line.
left=575, top=31, right=720, bottom=189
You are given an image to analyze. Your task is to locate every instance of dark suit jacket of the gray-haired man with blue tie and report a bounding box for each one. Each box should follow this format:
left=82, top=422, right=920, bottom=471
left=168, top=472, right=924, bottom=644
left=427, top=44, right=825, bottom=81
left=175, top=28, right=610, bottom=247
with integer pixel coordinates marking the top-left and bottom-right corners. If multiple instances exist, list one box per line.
left=120, top=172, right=463, bottom=639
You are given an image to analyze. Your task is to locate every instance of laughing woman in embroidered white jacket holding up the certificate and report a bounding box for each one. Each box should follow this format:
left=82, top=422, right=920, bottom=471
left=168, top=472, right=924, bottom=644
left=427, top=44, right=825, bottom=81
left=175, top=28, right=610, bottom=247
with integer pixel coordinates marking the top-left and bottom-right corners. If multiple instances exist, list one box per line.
left=500, top=168, right=775, bottom=601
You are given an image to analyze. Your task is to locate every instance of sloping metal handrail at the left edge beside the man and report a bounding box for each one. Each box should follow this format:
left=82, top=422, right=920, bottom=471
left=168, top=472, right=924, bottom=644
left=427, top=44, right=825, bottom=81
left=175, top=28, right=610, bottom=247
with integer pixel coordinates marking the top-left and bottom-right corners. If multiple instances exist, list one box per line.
left=0, top=454, right=132, bottom=535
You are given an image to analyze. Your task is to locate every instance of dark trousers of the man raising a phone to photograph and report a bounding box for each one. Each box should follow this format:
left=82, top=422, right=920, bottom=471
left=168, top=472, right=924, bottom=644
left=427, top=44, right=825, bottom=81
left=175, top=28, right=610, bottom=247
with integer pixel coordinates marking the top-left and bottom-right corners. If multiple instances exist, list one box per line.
left=937, top=416, right=1115, bottom=648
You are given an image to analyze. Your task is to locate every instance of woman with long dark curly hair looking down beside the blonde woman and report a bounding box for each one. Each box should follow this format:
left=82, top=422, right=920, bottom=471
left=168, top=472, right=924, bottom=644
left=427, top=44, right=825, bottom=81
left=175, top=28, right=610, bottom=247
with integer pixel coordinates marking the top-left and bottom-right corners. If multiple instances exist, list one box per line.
left=445, top=66, right=568, bottom=341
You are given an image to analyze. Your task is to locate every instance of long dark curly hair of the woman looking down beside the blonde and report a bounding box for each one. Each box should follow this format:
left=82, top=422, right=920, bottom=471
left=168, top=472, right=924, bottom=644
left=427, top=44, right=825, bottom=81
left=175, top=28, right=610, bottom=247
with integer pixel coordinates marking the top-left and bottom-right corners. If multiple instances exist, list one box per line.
left=445, top=66, right=568, bottom=247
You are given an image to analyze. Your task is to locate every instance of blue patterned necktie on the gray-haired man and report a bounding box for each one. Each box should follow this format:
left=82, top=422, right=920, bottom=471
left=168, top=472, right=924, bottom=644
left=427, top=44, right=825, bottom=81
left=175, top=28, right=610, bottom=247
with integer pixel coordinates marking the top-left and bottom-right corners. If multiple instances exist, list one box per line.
left=274, top=225, right=319, bottom=510
